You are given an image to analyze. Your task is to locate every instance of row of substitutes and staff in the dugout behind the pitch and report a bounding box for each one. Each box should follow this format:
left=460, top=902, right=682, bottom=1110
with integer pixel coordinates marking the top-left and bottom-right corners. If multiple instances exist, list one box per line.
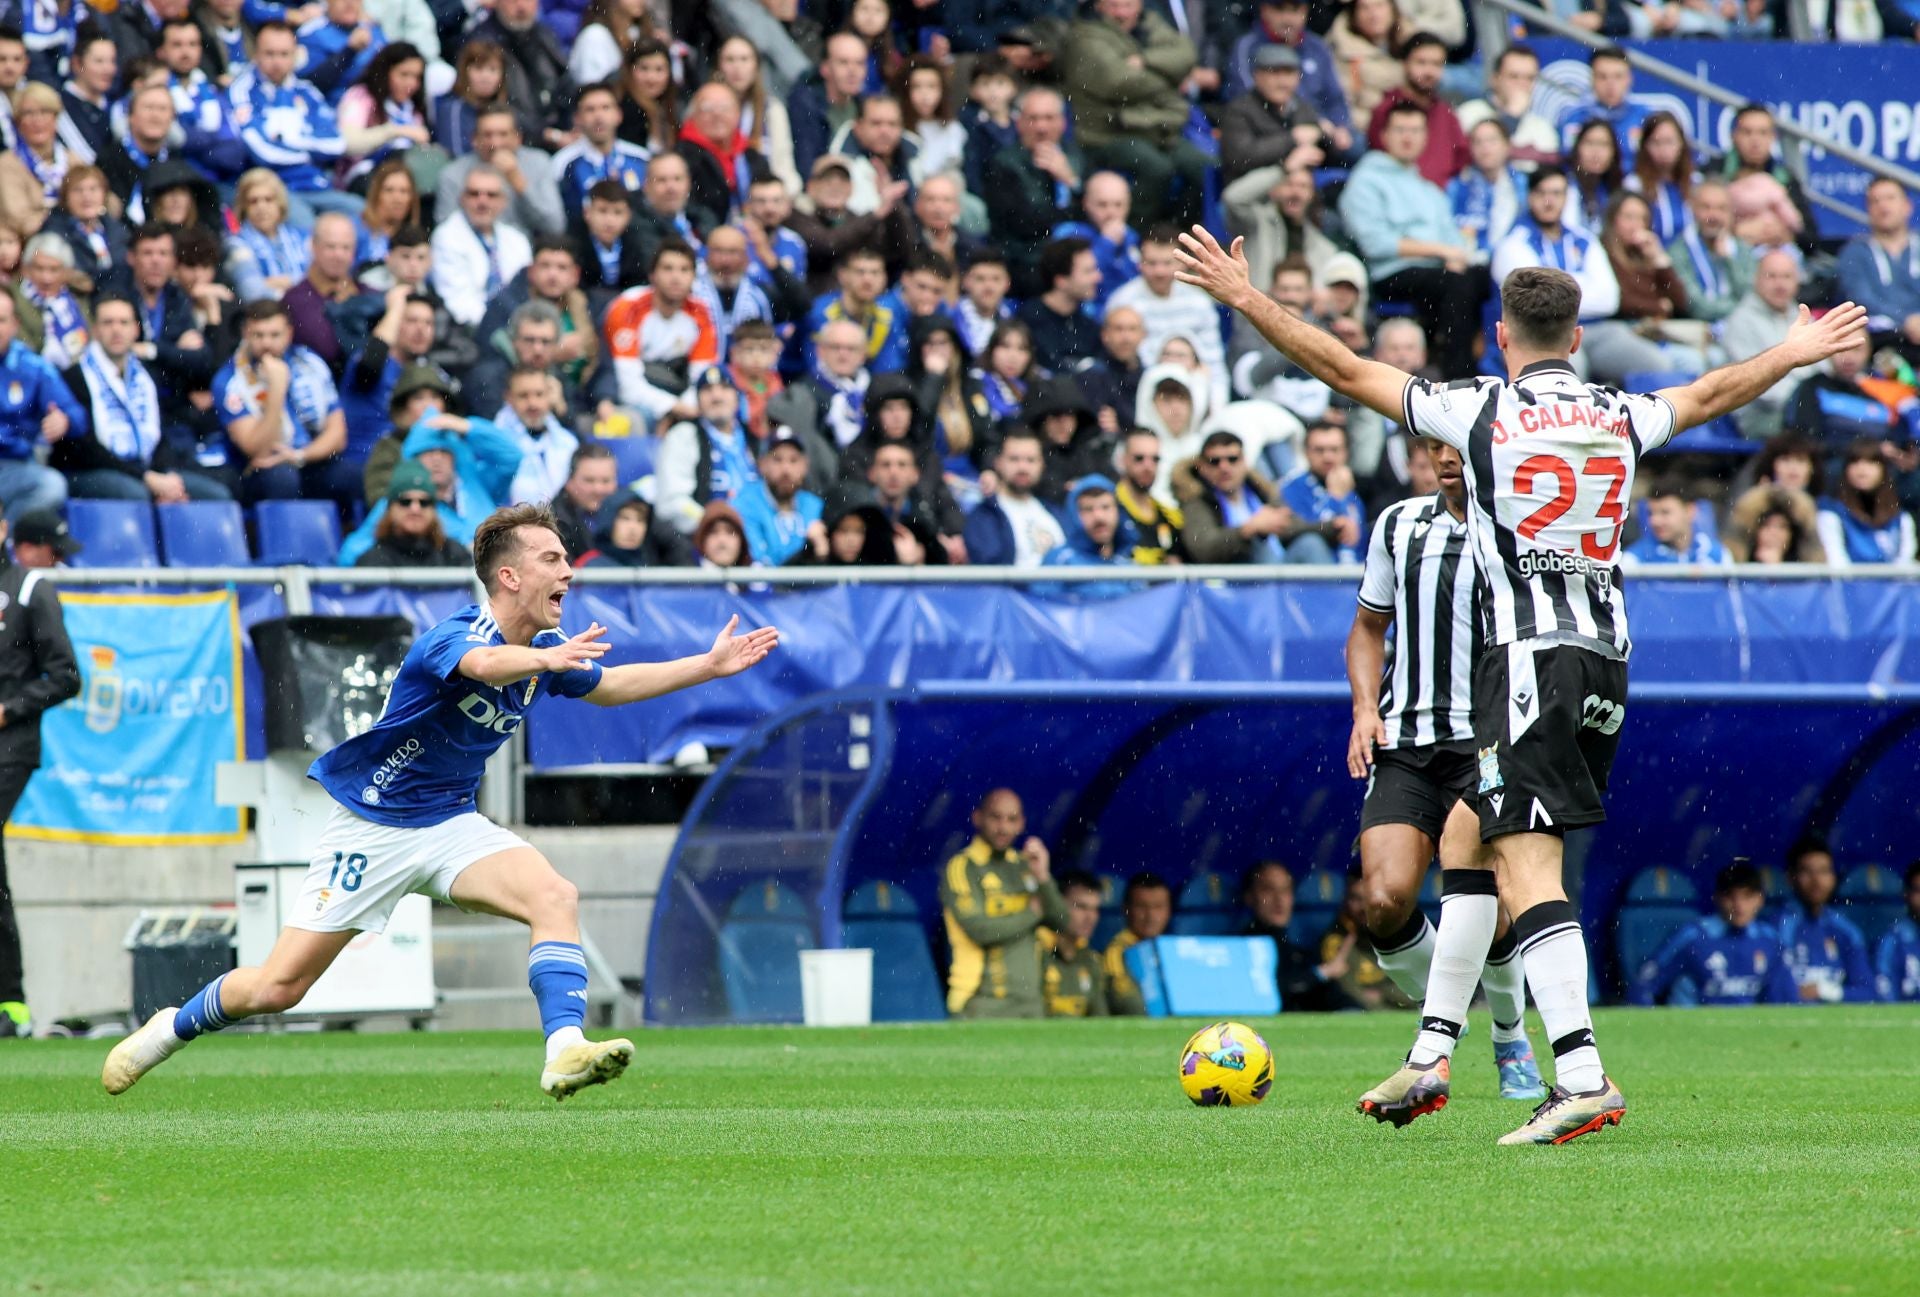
left=939, top=789, right=1920, bottom=1017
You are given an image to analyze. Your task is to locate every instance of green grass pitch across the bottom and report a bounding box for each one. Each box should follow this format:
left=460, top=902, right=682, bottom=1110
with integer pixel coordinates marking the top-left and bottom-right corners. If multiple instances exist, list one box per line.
left=0, top=1007, right=1920, bottom=1297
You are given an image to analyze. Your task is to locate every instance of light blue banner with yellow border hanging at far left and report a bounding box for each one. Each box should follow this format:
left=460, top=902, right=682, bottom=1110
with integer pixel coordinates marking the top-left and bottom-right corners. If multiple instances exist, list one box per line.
left=12, top=591, right=246, bottom=846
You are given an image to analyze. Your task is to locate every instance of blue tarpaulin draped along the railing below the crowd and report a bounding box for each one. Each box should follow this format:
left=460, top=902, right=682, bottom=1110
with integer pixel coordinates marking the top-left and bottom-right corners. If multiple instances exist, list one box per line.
left=529, top=578, right=1920, bottom=769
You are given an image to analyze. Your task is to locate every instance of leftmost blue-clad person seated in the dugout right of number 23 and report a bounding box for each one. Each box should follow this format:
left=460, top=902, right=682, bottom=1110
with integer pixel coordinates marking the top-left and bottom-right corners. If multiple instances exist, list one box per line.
left=1626, top=860, right=1799, bottom=1005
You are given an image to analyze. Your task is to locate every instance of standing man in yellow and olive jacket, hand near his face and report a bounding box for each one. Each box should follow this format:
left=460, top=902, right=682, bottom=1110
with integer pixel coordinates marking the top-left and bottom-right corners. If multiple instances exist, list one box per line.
left=941, top=789, right=1068, bottom=1017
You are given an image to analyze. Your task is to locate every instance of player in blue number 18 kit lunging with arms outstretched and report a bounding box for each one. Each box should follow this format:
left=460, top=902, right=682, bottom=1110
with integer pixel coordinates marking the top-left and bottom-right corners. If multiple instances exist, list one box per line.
left=100, top=505, right=780, bottom=1099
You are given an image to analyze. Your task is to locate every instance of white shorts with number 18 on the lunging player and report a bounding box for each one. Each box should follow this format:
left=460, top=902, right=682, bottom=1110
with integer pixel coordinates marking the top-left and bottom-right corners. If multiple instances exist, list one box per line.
left=286, top=804, right=526, bottom=932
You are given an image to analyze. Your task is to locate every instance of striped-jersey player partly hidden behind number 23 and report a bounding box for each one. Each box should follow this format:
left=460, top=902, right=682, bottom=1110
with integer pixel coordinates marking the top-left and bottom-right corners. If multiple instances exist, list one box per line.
left=1346, top=439, right=1546, bottom=1126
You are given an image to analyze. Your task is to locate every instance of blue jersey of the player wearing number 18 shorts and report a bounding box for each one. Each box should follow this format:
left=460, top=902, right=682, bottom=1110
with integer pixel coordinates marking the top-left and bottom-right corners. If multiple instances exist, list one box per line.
left=307, top=604, right=601, bottom=829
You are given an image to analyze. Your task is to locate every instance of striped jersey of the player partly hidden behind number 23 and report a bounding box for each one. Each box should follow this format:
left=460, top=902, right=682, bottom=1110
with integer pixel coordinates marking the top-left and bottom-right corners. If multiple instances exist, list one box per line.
left=1359, top=493, right=1480, bottom=748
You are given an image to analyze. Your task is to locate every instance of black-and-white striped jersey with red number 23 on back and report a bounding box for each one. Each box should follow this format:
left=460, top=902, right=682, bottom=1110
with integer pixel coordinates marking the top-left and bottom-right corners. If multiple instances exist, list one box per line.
left=1402, top=361, right=1678, bottom=658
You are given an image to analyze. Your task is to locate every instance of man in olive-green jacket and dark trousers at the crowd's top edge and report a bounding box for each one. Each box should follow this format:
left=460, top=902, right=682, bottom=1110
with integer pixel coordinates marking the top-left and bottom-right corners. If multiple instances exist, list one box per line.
left=1064, top=0, right=1213, bottom=230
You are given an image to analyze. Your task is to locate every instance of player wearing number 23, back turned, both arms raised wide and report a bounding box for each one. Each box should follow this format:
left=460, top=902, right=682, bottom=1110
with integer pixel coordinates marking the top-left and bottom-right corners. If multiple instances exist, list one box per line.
left=1181, top=226, right=1866, bottom=1144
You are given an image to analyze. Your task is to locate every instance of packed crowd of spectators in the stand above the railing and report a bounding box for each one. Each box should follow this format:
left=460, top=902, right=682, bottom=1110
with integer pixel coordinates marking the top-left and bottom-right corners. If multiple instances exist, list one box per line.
left=0, top=0, right=1920, bottom=571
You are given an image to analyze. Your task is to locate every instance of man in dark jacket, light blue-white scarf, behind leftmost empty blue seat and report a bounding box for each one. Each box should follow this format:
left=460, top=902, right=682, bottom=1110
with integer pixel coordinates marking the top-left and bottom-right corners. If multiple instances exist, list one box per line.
left=48, top=297, right=232, bottom=505
